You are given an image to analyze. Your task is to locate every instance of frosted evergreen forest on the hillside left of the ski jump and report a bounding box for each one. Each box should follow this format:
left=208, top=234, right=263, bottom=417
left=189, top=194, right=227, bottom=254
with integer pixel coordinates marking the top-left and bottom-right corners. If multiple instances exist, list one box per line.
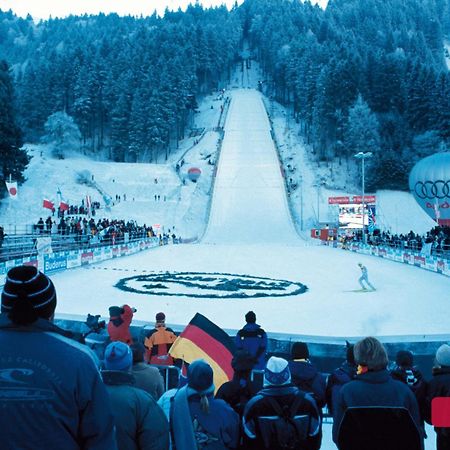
left=0, top=6, right=242, bottom=161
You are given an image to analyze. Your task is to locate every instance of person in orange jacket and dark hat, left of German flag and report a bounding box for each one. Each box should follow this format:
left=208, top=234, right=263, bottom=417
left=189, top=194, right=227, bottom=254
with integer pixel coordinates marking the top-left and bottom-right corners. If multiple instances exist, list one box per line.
left=144, top=312, right=177, bottom=366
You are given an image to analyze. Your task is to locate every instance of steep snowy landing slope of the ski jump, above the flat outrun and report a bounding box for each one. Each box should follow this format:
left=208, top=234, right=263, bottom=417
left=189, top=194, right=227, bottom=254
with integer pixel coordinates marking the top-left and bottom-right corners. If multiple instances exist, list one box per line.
left=202, top=90, right=298, bottom=244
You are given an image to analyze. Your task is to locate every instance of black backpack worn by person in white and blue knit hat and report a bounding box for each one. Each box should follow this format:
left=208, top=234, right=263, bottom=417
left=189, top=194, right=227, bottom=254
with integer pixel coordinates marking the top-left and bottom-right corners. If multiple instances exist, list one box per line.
left=257, top=392, right=311, bottom=450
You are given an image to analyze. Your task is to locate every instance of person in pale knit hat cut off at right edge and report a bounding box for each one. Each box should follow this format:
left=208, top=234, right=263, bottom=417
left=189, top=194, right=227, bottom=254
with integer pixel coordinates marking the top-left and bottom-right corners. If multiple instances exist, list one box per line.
left=424, top=344, right=450, bottom=450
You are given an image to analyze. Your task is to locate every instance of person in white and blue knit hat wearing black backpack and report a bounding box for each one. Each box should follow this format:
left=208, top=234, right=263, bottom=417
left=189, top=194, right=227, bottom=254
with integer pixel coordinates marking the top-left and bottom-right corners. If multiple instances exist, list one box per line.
left=242, top=356, right=322, bottom=450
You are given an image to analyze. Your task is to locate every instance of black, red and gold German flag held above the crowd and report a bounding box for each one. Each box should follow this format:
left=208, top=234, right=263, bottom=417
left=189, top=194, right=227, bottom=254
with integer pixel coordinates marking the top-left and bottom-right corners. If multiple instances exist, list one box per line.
left=169, top=313, right=235, bottom=390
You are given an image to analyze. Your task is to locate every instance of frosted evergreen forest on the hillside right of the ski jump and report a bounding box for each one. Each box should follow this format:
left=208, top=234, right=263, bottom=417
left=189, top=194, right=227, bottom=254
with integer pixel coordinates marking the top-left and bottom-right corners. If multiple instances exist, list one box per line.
left=243, top=0, right=450, bottom=188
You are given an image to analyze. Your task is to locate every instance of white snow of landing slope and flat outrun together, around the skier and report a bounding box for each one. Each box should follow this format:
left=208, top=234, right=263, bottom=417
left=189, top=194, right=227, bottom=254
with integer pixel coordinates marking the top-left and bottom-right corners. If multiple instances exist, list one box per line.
left=54, top=90, right=450, bottom=336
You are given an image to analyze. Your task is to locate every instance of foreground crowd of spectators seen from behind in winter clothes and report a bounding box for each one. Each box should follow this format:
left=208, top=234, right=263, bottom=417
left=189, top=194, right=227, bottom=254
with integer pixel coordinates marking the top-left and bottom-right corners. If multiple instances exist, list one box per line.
left=0, top=266, right=450, bottom=450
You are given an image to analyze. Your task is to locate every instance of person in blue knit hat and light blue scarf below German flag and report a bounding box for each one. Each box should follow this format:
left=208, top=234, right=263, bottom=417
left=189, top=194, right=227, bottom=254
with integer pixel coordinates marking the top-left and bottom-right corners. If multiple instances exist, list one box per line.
left=170, top=360, right=239, bottom=450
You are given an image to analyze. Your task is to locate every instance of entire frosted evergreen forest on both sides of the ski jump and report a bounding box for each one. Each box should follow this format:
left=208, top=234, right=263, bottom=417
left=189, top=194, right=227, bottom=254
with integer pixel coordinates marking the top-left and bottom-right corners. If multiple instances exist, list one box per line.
left=0, top=0, right=450, bottom=189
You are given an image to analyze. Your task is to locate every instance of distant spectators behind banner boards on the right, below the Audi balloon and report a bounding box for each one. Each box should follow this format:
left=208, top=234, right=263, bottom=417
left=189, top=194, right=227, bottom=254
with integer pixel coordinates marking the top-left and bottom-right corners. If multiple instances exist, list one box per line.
left=342, top=226, right=450, bottom=255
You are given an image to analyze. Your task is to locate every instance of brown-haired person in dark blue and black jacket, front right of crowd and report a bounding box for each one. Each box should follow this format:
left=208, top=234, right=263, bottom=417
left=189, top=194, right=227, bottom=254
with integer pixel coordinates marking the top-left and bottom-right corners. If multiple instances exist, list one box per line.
left=333, top=337, right=423, bottom=450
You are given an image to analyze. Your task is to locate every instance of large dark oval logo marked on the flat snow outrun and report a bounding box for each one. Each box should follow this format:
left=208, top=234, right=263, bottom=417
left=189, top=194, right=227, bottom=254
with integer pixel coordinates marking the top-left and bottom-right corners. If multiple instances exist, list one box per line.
left=116, top=272, right=308, bottom=299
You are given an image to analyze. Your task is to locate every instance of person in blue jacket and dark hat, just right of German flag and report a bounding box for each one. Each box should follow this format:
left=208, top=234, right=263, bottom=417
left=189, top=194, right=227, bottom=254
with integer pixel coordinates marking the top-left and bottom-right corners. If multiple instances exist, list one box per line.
left=235, top=311, right=267, bottom=370
